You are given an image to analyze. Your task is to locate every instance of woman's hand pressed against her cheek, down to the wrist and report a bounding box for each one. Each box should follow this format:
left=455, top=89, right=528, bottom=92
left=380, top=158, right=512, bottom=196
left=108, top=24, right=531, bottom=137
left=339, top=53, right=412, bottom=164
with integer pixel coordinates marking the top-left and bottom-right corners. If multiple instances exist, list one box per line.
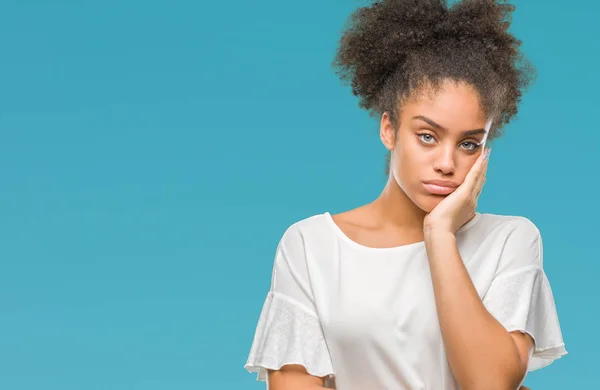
left=423, top=149, right=491, bottom=235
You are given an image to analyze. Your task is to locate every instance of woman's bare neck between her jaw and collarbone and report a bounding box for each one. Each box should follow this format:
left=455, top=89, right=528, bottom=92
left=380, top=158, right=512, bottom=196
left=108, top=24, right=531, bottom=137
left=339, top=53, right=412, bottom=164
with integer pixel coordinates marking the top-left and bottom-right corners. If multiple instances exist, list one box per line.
left=371, top=176, right=427, bottom=230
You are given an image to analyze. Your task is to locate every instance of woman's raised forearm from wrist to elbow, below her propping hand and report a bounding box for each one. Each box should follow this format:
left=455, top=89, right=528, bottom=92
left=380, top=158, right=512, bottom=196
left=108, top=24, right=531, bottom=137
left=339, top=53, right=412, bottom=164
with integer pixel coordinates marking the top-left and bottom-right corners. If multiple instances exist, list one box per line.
left=425, top=232, right=524, bottom=390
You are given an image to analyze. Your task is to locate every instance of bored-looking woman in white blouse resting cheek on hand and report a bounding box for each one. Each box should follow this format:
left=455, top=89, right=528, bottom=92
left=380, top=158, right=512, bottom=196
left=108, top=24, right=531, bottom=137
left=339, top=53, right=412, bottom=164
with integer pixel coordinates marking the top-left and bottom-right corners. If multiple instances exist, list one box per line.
left=245, top=0, right=566, bottom=390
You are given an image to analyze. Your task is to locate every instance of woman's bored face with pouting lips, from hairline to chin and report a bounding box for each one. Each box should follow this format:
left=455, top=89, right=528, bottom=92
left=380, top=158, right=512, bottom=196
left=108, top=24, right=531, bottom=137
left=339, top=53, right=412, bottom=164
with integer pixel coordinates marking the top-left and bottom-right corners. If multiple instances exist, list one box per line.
left=380, top=82, right=487, bottom=212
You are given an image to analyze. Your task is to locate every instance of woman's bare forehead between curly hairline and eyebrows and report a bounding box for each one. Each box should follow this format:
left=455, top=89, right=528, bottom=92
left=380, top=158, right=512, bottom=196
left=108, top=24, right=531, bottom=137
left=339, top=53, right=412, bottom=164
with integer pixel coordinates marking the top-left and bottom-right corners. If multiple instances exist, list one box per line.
left=401, top=81, right=487, bottom=131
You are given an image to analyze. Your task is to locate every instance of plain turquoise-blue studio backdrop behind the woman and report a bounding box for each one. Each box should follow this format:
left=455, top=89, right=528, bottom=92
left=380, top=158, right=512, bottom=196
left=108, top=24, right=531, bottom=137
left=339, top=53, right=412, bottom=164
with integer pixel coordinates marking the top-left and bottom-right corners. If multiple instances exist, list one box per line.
left=0, top=0, right=600, bottom=390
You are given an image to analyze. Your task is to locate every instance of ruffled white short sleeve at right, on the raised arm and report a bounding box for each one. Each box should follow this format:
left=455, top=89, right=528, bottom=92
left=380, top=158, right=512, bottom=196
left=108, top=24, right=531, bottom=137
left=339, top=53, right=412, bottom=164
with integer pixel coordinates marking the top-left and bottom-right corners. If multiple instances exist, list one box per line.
left=483, top=218, right=567, bottom=371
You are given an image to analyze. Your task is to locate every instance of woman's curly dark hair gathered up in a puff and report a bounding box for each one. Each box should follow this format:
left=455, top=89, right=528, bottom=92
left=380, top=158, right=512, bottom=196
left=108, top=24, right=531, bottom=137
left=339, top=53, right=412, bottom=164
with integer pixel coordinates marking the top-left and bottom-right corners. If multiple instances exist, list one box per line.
left=332, top=0, right=536, bottom=139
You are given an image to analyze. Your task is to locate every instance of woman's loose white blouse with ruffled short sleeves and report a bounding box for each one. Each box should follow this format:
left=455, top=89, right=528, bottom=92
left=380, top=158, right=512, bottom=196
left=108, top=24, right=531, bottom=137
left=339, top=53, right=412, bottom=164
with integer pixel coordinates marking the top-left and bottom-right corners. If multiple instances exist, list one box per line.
left=245, top=213, right=567, bottom=390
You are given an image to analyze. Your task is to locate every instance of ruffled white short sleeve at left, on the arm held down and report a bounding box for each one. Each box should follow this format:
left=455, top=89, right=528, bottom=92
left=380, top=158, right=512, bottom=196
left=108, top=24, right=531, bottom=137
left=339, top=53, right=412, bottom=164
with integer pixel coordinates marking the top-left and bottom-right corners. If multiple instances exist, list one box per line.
left=245, top=225, right=334, bottom=386
